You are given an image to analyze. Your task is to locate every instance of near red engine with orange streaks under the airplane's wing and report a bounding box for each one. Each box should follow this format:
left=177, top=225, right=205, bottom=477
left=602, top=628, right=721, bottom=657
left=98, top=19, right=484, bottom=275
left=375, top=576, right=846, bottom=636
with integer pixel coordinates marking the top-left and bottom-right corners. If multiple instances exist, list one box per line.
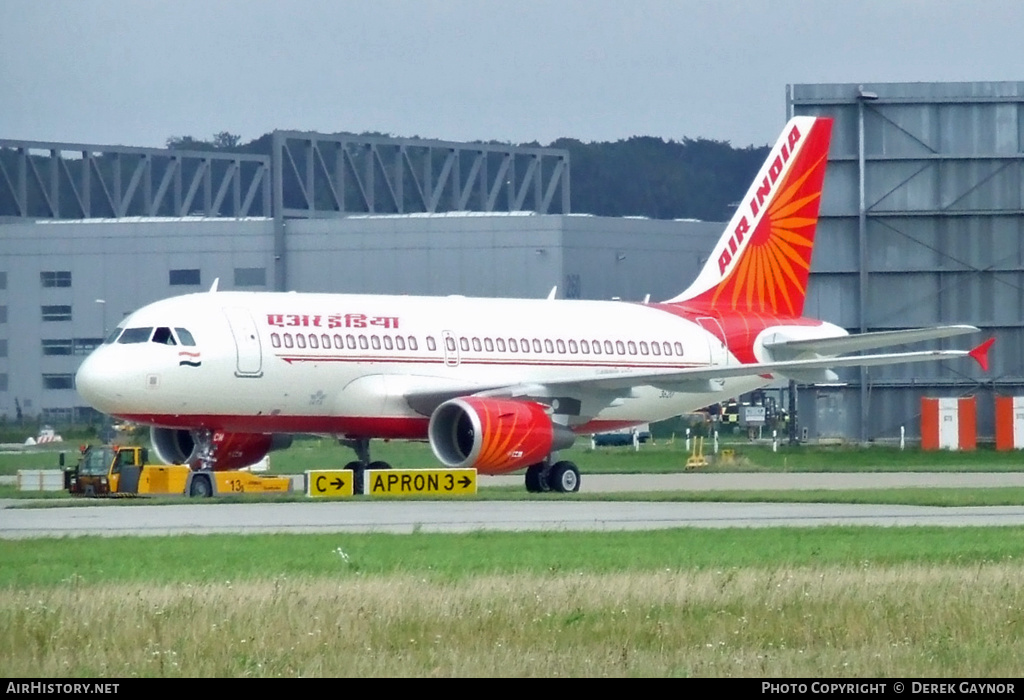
left=428, top=396, right=575, bottom=474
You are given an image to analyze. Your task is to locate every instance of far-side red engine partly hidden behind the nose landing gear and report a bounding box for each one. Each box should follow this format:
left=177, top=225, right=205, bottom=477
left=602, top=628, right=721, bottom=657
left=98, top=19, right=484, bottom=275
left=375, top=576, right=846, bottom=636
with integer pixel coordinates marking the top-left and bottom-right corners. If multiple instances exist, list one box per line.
left=150, top=428, right=292, bottom=472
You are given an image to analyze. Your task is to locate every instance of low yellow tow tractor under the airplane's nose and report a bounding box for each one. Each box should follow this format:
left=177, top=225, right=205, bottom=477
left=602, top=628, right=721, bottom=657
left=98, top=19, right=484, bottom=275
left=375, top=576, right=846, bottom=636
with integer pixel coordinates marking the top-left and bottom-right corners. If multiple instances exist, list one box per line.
left=60, top=445, right=292, bottom=497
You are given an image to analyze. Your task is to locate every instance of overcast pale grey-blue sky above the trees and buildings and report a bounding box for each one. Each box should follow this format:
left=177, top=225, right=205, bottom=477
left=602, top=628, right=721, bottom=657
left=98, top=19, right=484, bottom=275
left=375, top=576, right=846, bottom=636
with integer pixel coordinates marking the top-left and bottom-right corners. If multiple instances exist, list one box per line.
left=0, top=0, right=1024, bottom=146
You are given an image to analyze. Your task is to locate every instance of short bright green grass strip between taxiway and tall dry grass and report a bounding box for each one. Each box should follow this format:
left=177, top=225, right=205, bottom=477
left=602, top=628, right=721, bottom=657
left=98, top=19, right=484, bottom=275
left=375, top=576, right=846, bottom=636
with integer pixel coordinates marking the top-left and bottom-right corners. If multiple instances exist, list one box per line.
left=0, top=527, right=1024, bottom=589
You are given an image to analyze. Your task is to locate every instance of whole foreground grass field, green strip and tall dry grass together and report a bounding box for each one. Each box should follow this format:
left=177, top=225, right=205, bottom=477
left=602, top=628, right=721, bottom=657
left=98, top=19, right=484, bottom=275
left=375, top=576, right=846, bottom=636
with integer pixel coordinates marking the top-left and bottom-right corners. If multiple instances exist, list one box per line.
left=0, top=528, right=1024, bottom=677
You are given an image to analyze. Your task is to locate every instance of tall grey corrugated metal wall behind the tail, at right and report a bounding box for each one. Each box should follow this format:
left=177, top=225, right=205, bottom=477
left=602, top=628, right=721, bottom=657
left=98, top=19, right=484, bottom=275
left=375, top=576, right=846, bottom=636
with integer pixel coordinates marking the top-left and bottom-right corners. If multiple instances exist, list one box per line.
left=787, top=82, right=1024, bottom=440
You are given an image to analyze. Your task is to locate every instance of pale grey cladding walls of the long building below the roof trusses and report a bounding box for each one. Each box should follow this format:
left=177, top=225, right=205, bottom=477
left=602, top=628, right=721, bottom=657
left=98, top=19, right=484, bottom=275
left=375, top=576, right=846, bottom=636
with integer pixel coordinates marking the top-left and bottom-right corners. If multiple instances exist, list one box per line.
left=0, top=213, right=723, bottom=421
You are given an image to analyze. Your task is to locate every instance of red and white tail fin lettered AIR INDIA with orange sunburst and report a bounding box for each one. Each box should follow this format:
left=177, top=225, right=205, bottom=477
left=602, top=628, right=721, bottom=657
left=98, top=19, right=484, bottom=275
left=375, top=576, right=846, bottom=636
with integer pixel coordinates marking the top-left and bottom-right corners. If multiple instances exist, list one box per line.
left=669, top=117, right=833, bottom=316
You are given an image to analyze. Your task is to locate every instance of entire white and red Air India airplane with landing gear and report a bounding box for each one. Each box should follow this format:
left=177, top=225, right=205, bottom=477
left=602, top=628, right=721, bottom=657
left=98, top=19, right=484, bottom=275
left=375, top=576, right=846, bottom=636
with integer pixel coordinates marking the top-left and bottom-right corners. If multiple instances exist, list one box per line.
left=76, top=117, right=994, bottom=492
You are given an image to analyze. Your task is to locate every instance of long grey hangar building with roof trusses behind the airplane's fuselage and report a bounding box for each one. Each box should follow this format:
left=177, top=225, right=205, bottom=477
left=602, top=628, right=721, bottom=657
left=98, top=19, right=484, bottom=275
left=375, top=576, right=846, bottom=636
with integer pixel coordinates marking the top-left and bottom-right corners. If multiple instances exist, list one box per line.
left=0, top=132, right=722, bottom=423
